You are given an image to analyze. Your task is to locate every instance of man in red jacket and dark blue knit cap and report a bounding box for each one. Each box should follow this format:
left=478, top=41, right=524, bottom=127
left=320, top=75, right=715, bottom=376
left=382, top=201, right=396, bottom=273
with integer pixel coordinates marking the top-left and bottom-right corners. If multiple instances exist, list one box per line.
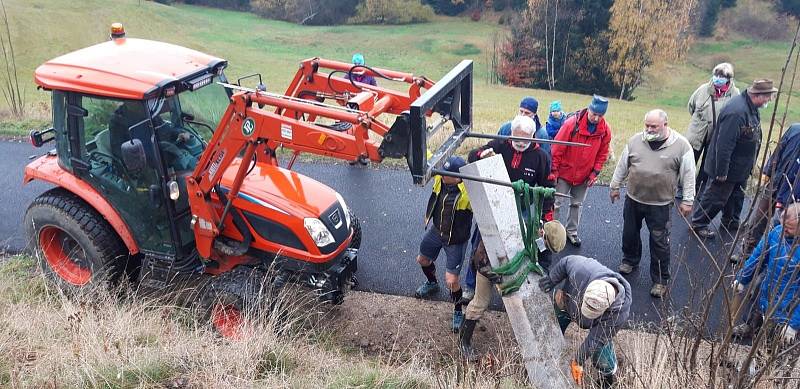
left=551, top=95, right=611, bottom=247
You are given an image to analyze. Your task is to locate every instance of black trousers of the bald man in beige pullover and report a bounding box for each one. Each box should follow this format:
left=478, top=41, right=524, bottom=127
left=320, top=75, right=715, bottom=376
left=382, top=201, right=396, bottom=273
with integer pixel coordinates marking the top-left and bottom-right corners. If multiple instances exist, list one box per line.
left=622, top=196, right=672, bottom=285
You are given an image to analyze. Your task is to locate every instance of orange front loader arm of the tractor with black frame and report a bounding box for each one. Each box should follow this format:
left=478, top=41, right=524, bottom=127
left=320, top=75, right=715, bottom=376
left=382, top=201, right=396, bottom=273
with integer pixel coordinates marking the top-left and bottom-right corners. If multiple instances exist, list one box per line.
left=187, top=58, right=472, bottom=258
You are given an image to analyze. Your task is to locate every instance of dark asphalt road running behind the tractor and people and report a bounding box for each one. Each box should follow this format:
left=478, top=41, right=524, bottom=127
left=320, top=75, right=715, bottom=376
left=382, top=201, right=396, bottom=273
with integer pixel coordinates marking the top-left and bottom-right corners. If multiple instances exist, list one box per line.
left=0, top=141, right=746, bottom=322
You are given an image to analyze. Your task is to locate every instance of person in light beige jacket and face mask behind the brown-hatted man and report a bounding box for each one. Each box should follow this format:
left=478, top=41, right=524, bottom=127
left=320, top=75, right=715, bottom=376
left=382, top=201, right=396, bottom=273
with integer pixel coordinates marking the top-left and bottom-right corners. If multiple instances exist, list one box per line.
left=678, top=62, right=739, bottom=191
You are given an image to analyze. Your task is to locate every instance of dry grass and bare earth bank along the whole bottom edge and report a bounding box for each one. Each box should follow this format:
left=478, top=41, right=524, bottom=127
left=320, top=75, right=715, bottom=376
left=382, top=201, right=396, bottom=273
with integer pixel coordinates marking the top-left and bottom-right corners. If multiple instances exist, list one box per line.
left=0, top=252, right=800, bottom=389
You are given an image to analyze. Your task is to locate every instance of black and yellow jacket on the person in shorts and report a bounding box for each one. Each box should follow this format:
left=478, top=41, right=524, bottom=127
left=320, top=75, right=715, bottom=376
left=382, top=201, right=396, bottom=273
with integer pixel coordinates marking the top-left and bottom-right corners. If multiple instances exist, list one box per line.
left=425, top=176, right=472, bottom=245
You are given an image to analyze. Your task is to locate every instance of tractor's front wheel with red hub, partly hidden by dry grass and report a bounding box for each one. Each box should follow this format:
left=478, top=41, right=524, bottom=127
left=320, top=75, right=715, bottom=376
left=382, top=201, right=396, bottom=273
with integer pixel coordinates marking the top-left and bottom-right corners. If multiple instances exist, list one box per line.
left=200, top=266, right=269, bottom=339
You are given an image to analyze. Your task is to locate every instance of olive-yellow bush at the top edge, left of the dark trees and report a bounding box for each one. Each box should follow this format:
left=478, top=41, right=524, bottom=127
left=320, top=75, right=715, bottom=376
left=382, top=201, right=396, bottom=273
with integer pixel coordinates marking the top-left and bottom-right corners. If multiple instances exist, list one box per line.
left=349, top=0, right=434, bottom=24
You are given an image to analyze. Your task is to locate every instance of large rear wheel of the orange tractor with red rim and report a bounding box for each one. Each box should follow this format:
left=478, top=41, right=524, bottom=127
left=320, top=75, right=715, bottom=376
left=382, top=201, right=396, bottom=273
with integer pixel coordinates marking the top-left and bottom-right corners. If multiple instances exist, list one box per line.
left=24, top=188, right=128, bottom=292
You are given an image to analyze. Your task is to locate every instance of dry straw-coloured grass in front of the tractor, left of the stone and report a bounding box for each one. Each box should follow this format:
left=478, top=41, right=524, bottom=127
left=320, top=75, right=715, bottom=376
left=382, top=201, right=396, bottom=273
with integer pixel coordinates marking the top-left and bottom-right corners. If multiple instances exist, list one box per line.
left=0, top=257, right=524, bottom=388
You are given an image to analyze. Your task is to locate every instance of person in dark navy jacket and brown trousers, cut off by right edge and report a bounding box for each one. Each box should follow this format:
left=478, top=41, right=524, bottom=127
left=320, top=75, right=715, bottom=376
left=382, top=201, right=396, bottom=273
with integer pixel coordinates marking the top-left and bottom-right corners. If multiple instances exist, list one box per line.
left=731, top=123, right=800, bottom=263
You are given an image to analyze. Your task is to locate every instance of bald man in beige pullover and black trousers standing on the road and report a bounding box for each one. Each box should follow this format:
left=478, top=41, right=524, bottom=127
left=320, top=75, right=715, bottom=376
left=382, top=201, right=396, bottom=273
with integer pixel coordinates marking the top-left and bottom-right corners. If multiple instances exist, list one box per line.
left=609, top=109, right=695, bottom=298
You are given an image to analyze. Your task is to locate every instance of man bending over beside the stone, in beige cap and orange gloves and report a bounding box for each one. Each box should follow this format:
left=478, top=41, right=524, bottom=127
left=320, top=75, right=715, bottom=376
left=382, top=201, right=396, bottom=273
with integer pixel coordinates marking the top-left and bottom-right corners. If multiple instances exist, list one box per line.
left=539, top=255, right=633, bottom=386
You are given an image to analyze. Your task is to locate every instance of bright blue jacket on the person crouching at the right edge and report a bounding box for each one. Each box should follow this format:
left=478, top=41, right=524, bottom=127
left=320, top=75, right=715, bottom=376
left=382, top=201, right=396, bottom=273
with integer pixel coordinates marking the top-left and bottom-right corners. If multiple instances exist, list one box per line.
left=736, top=226, right=800, bottom=330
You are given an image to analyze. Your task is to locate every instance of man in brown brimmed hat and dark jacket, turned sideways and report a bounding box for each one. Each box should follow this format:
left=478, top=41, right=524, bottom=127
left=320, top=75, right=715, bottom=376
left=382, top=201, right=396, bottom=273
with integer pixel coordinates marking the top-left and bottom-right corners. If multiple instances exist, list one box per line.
left=692, top=80, right=777, bottom=239
